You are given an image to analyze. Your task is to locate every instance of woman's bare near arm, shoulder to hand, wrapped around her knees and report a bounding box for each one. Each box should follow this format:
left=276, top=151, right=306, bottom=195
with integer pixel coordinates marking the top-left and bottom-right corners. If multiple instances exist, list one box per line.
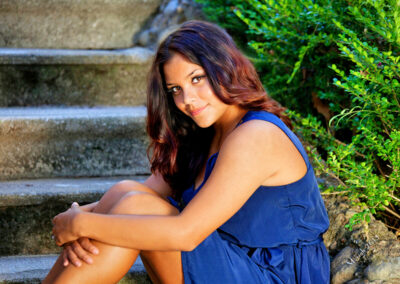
left=54, top=121, right=287, bottom=251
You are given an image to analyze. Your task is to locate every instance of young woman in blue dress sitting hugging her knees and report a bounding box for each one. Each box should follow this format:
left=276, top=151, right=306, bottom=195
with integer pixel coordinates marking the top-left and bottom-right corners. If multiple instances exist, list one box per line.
left=44, top=21, right=330, bottom=284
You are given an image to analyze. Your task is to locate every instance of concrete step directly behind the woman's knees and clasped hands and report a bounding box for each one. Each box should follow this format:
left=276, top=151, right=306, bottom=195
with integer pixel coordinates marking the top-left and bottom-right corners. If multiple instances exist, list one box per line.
left=0, top=176, right=147, bottom=255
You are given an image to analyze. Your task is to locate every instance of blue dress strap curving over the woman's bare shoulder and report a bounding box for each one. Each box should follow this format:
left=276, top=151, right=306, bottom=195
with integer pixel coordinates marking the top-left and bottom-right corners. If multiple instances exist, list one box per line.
left=236, top=110, right=310, bottom=168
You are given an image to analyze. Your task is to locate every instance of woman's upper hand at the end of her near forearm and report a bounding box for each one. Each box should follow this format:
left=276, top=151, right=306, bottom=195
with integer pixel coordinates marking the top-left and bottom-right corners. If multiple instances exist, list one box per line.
left=53, top=202, right=83, bottom=246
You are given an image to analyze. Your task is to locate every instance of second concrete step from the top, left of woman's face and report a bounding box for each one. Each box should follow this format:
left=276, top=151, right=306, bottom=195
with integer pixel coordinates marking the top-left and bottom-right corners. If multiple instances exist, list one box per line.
left=0, top=47, right=154, bottom=106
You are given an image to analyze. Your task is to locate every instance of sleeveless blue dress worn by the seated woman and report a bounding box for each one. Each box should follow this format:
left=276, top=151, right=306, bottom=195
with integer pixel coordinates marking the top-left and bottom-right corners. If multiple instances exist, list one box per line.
left=170, top=111, right=330, bottom=284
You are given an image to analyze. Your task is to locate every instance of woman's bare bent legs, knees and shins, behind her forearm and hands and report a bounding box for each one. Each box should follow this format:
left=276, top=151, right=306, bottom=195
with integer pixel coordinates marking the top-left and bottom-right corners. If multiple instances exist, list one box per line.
left=43, top=181, right=183, bottom=283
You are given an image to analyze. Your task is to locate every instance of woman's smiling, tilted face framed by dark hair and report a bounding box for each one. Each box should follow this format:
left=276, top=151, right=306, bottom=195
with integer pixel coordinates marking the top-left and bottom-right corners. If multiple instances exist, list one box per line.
left=164, top=53, right=230, bottom=128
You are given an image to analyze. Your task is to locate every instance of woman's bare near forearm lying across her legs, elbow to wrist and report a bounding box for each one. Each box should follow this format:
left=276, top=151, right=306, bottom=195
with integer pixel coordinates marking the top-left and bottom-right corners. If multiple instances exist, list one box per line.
left=75, top=212, right=194, bottom=251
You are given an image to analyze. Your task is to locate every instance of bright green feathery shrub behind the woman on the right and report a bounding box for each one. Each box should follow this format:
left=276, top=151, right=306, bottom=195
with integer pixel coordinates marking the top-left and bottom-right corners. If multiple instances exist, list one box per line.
left=201, top=0, right=400, bottom=231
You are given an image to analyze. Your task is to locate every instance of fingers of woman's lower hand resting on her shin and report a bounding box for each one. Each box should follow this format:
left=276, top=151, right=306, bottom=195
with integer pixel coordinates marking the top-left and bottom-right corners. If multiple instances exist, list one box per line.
left=62, top=237, right=99, bottom=267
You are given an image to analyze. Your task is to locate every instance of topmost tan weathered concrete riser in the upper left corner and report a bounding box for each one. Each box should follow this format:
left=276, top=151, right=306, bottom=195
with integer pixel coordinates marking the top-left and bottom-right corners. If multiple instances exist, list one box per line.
left=0, top=0, right=161, bottom=49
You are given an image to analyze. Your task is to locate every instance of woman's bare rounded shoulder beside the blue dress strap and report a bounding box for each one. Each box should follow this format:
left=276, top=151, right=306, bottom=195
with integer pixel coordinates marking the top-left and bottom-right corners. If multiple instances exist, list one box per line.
left=218, top=120, right=307, bottom=186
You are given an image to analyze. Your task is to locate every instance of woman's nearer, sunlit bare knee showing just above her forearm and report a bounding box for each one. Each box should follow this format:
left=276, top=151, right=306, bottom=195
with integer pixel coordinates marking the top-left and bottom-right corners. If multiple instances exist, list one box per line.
left=109, top=191, right=179, bottom=215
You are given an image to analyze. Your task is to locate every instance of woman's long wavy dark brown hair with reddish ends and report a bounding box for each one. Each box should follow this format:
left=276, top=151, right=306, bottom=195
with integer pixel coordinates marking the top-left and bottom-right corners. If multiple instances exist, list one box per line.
left=147, top=21, right=291, bottom=198
